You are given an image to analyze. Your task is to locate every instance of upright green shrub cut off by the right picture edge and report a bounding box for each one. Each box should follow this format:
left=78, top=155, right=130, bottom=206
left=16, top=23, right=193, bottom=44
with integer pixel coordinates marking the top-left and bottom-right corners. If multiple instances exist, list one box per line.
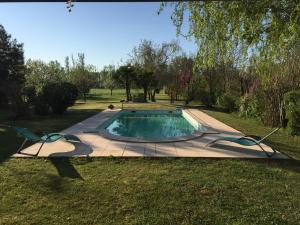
left=284, top=90, right=300, bottom=135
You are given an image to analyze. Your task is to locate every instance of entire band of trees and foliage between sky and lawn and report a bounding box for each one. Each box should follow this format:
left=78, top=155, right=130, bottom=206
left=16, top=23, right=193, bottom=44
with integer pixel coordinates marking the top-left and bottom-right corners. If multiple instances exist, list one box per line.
left=0, top=0, right=300, bottom=134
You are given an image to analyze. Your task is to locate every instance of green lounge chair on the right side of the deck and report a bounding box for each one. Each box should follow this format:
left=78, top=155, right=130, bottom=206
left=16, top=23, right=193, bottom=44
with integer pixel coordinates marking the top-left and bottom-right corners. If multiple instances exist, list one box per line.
left=207, top=128, right=280, bottom=157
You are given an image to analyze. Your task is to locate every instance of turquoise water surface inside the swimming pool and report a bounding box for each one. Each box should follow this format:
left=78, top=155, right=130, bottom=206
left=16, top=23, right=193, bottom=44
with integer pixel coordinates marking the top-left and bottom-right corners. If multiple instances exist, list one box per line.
left=105, top=110, right=195, bottom=140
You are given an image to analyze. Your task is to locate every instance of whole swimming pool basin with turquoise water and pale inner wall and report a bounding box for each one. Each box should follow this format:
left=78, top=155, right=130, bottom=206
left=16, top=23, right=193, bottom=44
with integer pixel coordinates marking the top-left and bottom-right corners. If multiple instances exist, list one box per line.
left=98, top=110, right=203, bottom=141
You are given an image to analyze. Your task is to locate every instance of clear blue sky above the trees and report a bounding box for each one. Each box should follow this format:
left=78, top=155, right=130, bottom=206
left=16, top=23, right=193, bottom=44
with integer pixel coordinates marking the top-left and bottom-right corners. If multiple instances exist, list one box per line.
left=0, top=2, right=196, bottom=69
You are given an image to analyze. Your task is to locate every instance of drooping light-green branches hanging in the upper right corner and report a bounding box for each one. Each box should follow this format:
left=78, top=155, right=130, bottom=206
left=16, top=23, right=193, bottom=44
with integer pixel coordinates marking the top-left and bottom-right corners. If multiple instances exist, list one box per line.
left=160, top=0, right=300, bottom=68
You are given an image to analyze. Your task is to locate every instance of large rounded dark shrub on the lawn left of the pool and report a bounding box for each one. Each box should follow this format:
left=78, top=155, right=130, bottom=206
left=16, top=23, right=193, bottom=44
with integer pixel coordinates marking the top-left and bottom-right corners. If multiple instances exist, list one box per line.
left=43, top=82, right=78, bottom=114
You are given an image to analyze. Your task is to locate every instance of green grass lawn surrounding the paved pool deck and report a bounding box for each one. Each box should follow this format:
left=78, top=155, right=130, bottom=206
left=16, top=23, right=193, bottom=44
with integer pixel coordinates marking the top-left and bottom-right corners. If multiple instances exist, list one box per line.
left=0, top=89, right=300, bottom=225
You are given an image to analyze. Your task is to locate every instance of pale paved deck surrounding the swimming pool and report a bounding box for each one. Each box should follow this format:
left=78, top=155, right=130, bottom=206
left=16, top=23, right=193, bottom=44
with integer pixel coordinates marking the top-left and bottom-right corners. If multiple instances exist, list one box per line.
left=14, top=109, right=288, bottom=158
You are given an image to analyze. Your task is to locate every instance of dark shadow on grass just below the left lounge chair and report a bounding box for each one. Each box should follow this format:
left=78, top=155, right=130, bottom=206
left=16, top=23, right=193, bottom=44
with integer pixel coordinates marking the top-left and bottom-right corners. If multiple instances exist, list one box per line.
left=49, top=157, right=83, bottom=180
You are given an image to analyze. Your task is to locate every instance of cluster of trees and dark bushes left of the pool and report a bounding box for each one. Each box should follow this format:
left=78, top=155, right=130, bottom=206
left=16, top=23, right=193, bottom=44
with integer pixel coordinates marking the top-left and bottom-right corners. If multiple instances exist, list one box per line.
left=0, top=25, right=98, bottom=118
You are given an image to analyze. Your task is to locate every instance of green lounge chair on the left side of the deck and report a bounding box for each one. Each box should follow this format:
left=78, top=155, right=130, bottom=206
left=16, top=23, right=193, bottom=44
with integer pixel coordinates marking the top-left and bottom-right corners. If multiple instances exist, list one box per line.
left=13, top=127, right=81, bottom=156
